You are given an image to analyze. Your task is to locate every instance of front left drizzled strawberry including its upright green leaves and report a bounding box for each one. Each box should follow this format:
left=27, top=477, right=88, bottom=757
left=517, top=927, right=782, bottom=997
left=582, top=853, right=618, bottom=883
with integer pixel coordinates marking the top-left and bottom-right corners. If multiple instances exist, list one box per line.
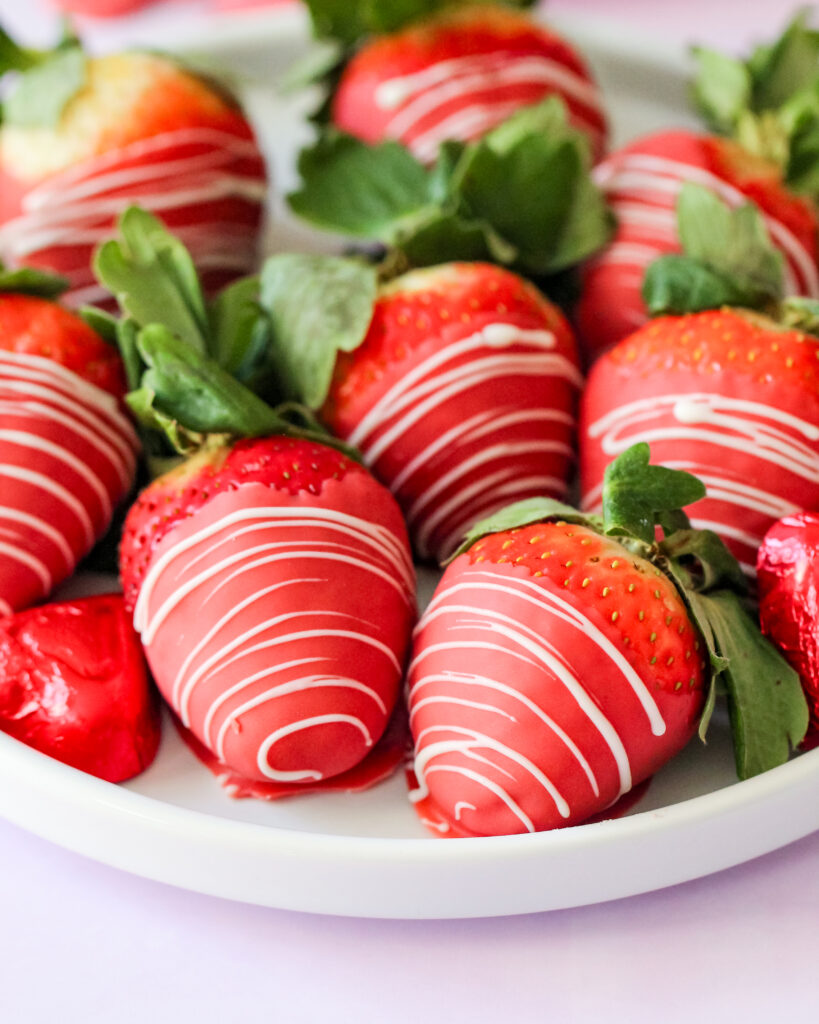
left=96, top=210, right=415, bottom=788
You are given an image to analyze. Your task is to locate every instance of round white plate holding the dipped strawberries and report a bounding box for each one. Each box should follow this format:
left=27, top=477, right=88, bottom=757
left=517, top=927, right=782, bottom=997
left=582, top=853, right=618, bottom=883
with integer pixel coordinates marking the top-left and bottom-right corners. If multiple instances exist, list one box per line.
left=0, top=12, right=819, bottom=918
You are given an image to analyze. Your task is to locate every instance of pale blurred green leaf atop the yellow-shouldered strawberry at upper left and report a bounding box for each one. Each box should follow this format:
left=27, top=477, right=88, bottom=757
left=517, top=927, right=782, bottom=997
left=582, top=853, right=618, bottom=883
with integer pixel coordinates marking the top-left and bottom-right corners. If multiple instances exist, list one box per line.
left=0, top=46, right=87, bottom=128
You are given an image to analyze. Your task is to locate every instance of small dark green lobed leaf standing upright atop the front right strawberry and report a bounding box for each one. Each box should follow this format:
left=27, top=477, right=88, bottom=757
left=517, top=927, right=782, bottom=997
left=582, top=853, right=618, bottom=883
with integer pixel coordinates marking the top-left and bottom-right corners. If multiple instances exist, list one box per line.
left=603, top=443, right=705, bottom=545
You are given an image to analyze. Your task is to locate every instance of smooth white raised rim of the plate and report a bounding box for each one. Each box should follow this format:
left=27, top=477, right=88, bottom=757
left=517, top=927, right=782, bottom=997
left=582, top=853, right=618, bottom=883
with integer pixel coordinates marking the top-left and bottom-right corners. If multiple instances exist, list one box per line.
left=0, top=7, right=819, bottom=920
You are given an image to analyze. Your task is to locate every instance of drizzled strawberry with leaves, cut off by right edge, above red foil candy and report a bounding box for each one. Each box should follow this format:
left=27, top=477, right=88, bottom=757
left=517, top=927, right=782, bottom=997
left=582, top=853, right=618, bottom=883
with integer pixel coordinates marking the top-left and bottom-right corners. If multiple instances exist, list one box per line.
left=579, top=185, right=819, bottom=573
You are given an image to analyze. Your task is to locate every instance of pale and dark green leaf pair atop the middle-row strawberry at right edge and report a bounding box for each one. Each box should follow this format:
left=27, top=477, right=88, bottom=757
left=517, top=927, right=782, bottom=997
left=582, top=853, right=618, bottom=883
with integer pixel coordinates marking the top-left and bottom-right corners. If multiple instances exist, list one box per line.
left=643, top=182, right=784, bottom=315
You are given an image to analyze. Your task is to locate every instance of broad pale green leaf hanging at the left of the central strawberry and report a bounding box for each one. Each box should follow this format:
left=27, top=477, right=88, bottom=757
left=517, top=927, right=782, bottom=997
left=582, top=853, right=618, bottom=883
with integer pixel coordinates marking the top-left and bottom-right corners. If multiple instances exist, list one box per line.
left=261, top=254, right=378, bottom=409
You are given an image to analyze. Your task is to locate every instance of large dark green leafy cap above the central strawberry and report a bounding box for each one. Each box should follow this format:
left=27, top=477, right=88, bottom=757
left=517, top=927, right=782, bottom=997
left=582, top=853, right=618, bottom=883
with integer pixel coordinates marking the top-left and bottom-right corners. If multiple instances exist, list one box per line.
left=288, top=95, right=612, bottom=276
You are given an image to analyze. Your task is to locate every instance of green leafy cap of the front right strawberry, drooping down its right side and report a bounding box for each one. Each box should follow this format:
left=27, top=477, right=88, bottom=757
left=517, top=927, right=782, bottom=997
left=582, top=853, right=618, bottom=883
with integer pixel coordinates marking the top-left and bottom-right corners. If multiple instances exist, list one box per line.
left=452, top=443, right=808, bottom=779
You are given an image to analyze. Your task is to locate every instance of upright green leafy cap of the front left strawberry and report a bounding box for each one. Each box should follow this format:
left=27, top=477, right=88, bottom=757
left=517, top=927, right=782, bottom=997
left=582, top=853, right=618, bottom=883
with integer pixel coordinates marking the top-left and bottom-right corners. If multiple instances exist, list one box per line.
left=92, top=207, right=362, bottom=471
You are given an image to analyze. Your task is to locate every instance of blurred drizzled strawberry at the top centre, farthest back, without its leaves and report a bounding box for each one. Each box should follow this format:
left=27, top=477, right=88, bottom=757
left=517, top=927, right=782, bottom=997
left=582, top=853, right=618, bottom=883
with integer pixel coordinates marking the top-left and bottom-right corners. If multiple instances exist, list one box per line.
left=325, top=0, right=606, bottom=164
